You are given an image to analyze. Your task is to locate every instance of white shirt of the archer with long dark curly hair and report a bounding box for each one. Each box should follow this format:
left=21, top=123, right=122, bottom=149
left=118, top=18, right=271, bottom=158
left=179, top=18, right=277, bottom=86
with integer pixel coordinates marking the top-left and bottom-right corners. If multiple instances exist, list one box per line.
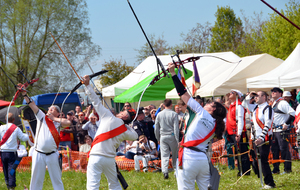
left=183, top=97, right=215, bottom=160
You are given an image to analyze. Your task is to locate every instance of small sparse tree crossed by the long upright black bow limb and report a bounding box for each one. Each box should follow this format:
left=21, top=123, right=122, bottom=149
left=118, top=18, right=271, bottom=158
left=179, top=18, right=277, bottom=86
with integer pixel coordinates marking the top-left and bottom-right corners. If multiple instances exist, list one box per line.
left=135, top=34, right=170, bottom=63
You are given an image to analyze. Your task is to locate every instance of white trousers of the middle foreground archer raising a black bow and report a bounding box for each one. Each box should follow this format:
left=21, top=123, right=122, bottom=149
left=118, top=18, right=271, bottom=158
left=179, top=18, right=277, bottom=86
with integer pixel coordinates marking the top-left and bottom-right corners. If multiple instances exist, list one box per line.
left=86, top=155, right=122, bottom=190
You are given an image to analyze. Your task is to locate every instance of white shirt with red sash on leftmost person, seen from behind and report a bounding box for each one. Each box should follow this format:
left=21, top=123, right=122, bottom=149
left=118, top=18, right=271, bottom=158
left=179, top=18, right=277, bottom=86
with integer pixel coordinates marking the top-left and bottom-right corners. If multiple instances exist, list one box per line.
left=0, top=123, right=29, bottom=152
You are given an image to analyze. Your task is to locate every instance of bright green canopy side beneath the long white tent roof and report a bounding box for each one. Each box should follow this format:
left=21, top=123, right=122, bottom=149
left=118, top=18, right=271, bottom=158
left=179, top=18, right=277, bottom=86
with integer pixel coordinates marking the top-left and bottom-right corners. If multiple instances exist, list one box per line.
left=114, top=69, right=193, bottom=103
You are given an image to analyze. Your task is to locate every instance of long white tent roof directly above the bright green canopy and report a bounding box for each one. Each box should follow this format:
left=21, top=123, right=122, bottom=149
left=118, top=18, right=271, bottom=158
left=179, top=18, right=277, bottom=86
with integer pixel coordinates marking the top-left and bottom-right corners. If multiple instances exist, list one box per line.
left=102, top=52, right=239, bottom=97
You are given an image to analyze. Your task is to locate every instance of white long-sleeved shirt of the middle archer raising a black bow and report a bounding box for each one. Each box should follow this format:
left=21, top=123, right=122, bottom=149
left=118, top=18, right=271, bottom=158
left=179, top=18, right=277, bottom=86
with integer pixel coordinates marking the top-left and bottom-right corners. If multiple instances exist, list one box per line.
left=84, top=85, right=138, bottom=157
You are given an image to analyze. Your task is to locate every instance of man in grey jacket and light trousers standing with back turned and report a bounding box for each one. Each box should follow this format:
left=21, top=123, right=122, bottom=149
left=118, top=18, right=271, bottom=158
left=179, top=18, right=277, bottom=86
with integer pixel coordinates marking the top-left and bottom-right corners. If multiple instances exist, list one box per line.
left=155, top=99, right=179, bottom=179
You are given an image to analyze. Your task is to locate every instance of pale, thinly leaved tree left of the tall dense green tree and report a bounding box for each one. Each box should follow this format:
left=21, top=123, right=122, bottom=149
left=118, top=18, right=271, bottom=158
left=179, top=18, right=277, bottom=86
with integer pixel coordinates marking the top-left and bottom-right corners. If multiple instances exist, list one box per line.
left=171, top=22, right=212, bottom=53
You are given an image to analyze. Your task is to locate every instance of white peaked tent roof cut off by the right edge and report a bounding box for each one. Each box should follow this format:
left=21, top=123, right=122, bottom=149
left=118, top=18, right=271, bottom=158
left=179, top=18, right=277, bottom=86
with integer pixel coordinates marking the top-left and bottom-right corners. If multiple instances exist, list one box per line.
left=247, top=43, right=300, bottom=90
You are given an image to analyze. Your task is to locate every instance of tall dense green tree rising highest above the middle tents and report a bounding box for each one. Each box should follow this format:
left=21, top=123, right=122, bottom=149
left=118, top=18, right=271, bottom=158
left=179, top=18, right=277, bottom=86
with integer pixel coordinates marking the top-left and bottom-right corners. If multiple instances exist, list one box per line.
left=209, top=6, right=244, bottom=52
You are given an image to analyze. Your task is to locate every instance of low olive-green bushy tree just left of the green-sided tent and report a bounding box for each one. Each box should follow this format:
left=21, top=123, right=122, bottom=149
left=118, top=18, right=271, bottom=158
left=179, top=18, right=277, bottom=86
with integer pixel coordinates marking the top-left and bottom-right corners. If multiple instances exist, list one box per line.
left=100, top=58, right=134, bottom=87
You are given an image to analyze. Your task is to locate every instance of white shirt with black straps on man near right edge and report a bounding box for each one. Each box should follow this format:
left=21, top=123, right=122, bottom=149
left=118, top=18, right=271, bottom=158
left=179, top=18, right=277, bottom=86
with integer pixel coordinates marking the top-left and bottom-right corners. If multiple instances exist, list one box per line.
left=272, top=98, right=295, bottom=132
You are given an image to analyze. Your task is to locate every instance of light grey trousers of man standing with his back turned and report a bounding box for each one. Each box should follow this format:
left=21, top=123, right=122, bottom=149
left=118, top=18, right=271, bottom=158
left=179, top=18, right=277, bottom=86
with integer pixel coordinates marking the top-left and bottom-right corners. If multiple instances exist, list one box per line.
left=160, top=135, right=178, bottom=173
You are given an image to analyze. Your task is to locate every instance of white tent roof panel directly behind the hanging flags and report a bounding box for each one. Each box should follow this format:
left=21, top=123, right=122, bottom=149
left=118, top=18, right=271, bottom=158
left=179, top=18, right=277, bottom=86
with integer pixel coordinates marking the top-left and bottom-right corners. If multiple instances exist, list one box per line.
left=166, top=52, right=241, bottom=99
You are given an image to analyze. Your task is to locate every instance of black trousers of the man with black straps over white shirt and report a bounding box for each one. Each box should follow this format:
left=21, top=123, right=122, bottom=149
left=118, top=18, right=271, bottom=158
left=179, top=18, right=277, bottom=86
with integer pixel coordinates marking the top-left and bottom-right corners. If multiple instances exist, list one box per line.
left=271, top=131, right=292, bottom=173
